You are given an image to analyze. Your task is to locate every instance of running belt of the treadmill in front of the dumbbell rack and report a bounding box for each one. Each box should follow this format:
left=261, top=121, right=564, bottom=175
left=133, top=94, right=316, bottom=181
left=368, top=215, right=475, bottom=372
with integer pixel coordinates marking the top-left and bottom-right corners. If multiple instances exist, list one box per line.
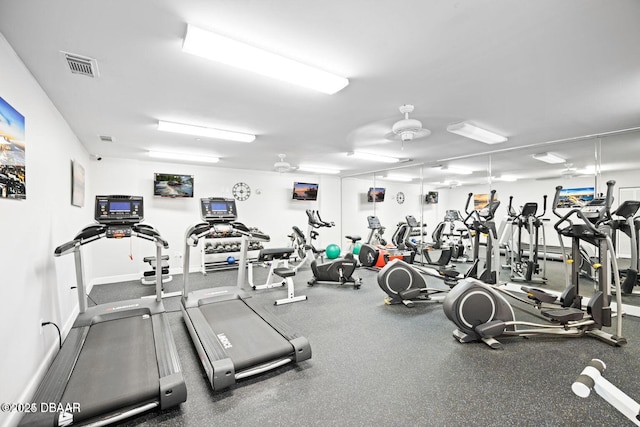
left=200, top=299, right=293, bottom=371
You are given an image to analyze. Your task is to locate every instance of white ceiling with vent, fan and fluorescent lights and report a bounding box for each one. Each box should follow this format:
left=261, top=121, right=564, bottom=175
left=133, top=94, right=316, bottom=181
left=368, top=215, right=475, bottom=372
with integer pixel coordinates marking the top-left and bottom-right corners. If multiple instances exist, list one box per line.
left=0, top=0, right=640, bottom=180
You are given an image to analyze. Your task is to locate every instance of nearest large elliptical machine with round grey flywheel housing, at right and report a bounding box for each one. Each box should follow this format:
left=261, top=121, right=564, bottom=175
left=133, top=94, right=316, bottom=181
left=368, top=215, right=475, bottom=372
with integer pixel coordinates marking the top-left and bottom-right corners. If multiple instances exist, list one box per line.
left=443, top=181, right=627, bottom=349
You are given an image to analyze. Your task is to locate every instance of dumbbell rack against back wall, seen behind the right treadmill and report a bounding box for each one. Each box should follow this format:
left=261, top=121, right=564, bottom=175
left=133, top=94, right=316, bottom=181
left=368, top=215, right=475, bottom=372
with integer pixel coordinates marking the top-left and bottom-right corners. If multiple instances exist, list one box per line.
left=200, top=229, right=263, bottom=275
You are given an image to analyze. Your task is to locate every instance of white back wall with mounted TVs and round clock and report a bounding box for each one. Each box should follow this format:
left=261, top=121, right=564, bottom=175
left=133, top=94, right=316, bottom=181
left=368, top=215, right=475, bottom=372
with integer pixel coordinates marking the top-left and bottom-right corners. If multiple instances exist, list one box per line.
left=87, top=158, right=341, bottom=283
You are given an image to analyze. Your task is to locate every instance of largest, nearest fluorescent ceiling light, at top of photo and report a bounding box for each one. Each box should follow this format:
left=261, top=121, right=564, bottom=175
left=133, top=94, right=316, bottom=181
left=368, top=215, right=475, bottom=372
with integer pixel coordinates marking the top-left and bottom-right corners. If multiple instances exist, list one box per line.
left=182, top=24, right=349, bottom=95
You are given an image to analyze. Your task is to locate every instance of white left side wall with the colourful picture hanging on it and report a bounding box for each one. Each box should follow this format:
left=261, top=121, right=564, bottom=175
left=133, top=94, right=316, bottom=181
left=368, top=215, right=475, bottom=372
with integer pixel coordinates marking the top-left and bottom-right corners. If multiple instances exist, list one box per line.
left=0, top=35, right=91, bottom=425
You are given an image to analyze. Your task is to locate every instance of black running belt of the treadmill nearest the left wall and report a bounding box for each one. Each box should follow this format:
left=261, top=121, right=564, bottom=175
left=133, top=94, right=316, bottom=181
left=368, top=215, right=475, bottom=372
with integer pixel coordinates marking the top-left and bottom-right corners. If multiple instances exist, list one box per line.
left=61, top=316, right=160, bottom=424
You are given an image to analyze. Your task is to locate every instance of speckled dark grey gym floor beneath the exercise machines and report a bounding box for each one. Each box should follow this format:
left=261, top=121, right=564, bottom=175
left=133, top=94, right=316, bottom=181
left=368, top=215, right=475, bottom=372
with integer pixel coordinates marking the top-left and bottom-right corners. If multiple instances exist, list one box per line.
left=90, top=262, right=640, bottom=426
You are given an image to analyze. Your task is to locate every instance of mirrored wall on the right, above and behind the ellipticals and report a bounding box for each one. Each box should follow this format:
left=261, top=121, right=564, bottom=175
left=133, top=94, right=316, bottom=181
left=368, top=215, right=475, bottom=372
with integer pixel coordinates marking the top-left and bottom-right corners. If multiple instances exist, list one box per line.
left=341, top=130, right=640, bottom=300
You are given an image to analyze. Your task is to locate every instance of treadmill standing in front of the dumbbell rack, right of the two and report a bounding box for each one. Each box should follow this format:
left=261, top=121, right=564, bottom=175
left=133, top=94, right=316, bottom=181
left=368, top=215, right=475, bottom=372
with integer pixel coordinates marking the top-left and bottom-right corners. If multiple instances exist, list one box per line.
left=181, top=197, right=311, bottom=391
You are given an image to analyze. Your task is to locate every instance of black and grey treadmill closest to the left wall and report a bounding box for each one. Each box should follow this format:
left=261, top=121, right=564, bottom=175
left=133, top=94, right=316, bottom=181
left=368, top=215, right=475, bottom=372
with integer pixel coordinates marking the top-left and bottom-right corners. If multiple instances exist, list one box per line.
left=20, top=196, right=187, bottom=426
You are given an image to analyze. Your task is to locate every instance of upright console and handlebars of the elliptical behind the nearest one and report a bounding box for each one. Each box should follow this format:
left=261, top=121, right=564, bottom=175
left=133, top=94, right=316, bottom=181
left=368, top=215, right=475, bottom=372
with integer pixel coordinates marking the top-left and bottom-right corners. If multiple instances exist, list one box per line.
left=464, top=190, right=500, bottom=284
